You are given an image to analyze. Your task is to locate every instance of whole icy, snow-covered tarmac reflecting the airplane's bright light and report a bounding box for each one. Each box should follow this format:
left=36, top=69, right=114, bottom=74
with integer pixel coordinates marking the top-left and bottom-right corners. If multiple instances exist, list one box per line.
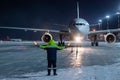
left=0, top=42, right=120, bottom=80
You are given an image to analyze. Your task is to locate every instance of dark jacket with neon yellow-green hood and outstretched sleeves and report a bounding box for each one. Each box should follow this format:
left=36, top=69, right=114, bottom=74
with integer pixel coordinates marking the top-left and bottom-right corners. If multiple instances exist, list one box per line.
left=40, top=40, right=65, bottom=61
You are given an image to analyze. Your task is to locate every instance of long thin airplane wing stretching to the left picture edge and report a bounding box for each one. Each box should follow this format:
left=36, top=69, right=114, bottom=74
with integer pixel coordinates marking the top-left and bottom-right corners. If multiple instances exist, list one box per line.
left=0, top=27, right=68, bottom=34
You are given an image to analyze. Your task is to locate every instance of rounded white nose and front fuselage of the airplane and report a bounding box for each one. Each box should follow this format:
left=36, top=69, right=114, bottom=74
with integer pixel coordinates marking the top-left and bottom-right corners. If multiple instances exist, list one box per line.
left=69, top=18, right=90, bottom=39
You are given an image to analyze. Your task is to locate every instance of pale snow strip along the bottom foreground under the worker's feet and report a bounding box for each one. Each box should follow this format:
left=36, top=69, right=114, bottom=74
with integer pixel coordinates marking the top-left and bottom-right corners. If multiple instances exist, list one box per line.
left=2, top=63, right=120, bottom=80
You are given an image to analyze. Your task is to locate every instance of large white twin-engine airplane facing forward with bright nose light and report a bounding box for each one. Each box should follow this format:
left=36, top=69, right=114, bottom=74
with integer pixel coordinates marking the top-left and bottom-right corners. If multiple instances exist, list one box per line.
left=0, top=2, right=120, bottom=46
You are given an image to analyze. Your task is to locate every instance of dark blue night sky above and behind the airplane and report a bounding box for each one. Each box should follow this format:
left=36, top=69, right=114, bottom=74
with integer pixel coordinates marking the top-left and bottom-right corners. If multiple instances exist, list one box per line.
left=0, top=0, right=120, bottom=39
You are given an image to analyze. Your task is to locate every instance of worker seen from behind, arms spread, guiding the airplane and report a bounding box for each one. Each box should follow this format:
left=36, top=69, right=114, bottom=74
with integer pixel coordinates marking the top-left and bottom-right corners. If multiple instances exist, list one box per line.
left=34, top=39, right=65, bottom=76
